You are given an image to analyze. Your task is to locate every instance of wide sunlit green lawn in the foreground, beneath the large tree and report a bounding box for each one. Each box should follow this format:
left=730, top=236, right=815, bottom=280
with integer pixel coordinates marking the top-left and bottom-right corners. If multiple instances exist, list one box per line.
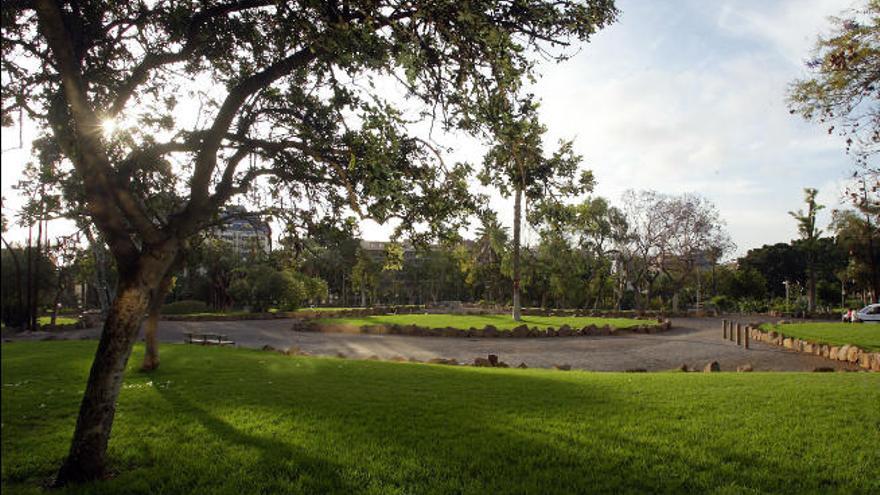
left=2, top=341, right=880, bottom=494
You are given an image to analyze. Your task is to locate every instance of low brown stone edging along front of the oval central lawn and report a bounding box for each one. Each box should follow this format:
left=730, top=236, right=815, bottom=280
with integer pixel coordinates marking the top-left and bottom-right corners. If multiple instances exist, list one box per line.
left=291, top=319, right=672, bottom=338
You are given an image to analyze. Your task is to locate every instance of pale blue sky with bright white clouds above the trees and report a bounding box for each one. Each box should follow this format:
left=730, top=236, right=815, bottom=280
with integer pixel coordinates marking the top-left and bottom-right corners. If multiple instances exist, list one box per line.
left=2, top=0, right=858, bottom=257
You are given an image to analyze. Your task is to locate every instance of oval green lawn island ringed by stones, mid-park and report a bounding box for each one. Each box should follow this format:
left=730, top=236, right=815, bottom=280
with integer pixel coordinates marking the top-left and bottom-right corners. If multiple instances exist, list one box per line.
left=315, top=314, right=644, bottom=330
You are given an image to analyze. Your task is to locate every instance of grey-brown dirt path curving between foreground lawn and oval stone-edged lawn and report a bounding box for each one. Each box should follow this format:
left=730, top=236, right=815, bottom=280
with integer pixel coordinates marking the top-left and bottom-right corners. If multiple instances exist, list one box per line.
left=5, top=318, right=858, bottom=371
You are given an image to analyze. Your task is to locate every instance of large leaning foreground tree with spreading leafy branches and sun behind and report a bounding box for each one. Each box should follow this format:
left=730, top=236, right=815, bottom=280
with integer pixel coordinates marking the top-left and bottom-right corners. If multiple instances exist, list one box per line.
left=2, top=0, right=616, bottom=484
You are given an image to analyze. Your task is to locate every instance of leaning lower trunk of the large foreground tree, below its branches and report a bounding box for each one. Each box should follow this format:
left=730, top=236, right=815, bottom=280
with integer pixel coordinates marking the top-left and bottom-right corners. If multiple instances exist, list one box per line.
left=55, top=277, right=150, bottom=486
